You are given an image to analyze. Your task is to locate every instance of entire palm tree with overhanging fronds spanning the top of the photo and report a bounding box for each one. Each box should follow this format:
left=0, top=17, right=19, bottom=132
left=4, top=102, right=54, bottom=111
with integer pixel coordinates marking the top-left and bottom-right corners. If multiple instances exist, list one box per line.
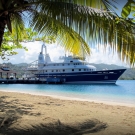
left=0, top=0, right=135, bottom=64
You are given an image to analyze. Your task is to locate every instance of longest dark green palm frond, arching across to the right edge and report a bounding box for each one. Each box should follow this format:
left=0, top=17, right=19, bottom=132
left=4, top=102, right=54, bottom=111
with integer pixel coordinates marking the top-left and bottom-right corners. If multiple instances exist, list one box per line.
left=28, top=0, right=134, bottom=65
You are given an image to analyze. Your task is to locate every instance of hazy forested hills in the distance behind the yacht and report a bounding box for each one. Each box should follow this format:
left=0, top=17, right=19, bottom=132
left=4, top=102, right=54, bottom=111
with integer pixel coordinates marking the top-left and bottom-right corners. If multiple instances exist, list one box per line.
left=0, top=63, right=135, bottom=80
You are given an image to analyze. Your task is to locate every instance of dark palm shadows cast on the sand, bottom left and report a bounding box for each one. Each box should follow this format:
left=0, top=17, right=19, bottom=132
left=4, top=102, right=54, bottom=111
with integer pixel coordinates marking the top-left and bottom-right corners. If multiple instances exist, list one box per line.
left=0, top=96, right=107, bottom=135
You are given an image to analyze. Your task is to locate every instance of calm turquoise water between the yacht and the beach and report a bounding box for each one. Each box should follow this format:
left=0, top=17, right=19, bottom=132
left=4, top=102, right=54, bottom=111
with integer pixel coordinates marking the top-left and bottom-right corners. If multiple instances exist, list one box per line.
left=0, top=80, right=135, bottom=105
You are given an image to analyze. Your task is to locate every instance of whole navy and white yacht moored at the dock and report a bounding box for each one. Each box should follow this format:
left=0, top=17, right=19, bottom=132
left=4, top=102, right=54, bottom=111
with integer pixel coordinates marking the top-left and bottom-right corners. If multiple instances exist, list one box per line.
left=27, top=44, right=126, bottom=84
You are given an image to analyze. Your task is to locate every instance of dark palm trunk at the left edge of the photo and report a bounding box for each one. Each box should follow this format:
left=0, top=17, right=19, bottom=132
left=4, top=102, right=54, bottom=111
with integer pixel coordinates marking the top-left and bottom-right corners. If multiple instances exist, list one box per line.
left=0, top=16, right=6, bottom=50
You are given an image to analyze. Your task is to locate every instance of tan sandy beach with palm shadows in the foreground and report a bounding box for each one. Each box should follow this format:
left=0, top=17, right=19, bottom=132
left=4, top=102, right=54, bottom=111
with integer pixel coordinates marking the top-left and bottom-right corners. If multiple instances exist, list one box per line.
left=0, top=91, right=135, bottom=135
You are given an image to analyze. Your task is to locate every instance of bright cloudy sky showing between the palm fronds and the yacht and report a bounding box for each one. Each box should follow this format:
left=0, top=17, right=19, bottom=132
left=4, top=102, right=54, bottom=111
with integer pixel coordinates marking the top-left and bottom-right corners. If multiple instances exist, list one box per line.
left=0, top=0, right=128, bottom=66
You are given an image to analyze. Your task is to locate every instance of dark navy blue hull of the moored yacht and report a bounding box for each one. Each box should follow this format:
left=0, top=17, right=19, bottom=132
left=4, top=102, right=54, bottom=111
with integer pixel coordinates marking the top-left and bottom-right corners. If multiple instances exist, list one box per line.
left=36, top=69, right=126, bottom=84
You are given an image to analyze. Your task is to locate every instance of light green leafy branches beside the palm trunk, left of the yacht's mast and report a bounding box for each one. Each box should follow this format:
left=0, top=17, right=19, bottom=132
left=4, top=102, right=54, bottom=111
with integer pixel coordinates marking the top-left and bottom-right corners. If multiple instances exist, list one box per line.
left=0, top=28, right=55, bottom=60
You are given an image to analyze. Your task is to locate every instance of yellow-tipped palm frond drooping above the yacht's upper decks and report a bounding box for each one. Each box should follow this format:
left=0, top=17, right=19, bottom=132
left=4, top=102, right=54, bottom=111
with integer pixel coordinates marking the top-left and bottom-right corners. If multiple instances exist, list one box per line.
left=31, top=12, right=90, bottom=56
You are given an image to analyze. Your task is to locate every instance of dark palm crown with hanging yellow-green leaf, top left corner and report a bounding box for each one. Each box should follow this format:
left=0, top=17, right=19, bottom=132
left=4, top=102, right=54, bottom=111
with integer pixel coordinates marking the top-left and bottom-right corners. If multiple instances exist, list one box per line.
left=0, top=0, right=31, bottom=48
